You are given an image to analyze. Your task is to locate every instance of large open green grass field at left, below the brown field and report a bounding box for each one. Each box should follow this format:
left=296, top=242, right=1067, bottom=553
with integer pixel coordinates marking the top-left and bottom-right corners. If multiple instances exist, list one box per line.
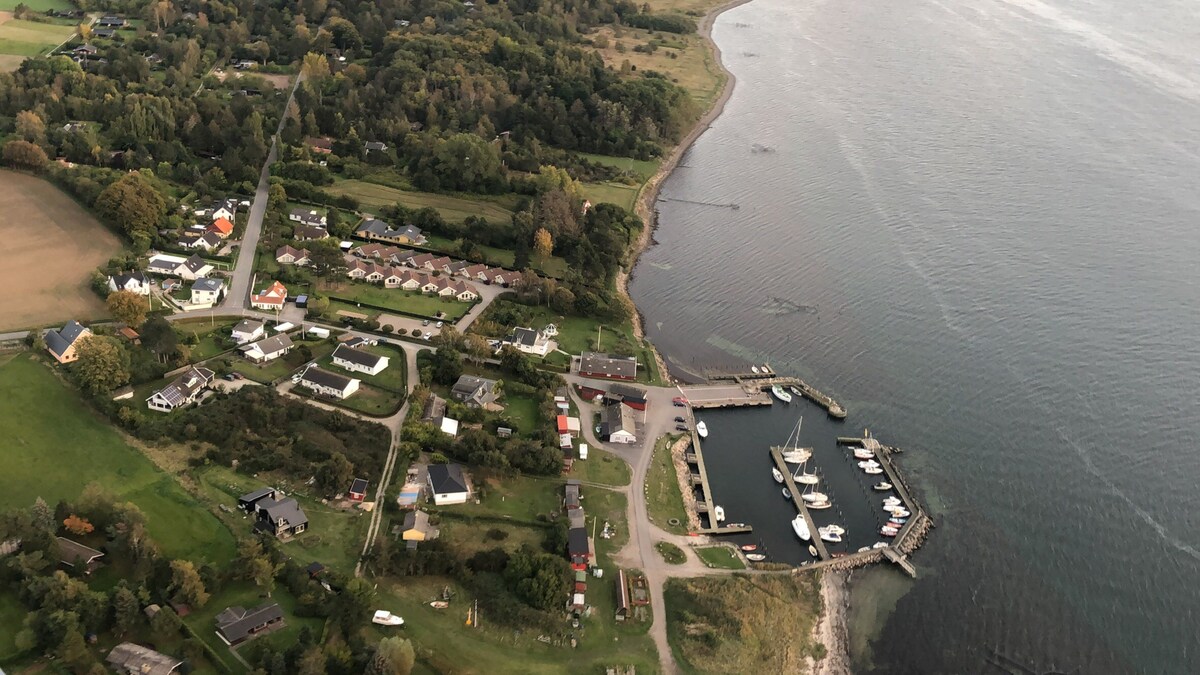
left=0, top=354, right=234, bottom=563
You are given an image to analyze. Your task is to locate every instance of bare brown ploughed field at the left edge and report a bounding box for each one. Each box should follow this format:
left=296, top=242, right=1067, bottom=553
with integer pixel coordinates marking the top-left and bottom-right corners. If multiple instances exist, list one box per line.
left=0, top=170, right=121, bottom=329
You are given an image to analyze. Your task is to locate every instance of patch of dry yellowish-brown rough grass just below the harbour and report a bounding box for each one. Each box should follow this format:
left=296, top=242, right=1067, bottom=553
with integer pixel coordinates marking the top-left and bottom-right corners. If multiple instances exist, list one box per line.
left=666, top=574, right=824, bottom=673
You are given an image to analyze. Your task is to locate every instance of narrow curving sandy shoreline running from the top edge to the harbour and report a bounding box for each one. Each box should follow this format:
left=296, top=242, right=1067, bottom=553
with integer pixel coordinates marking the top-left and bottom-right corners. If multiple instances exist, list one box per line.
left=617, top=0, right=752, bottom=382
